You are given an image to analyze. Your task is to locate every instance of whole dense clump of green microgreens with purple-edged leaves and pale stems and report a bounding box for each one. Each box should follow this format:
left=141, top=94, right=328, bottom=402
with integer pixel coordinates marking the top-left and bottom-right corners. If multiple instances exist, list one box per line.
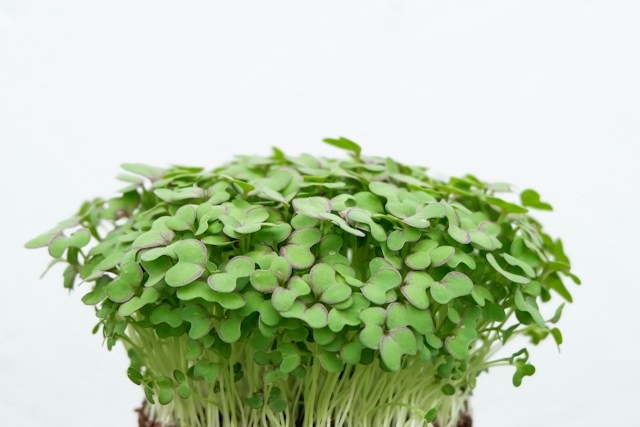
left=26, top=138, right=578, bottom=426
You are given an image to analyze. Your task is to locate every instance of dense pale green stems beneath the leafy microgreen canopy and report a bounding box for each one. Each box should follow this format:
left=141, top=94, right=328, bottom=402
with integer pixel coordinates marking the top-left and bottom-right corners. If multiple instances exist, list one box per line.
left=123, top=325, right=496, bottom=427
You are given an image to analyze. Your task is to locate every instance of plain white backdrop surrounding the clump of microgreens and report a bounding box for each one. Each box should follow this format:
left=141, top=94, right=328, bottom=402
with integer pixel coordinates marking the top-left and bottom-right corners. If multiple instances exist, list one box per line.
left=0, top=0, right=640, bottom=427
